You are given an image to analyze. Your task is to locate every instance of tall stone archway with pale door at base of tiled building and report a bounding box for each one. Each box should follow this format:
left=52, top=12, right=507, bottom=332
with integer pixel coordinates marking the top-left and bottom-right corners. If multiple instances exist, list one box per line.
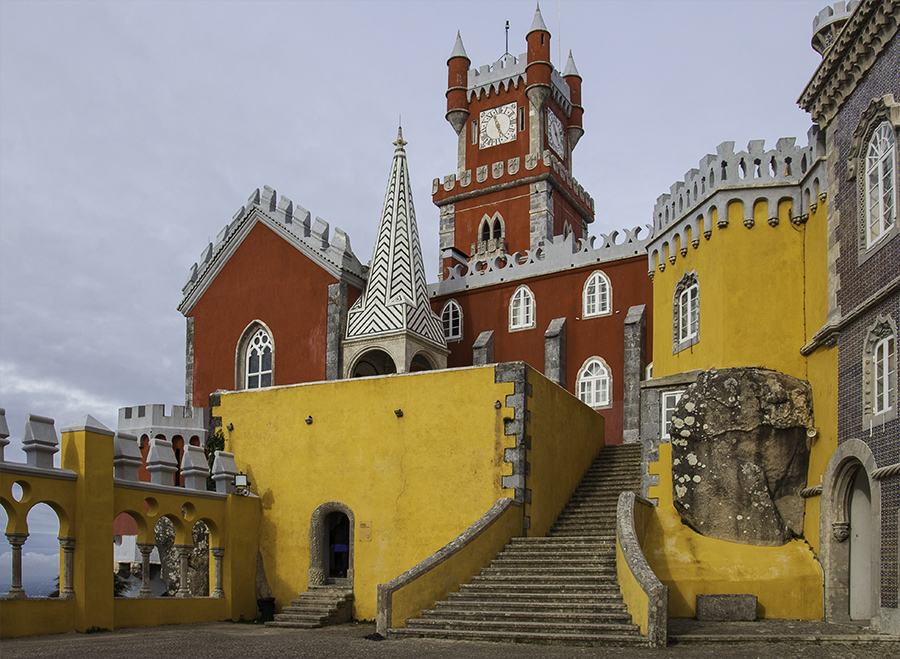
left=819, top=439, right=881, bottom=622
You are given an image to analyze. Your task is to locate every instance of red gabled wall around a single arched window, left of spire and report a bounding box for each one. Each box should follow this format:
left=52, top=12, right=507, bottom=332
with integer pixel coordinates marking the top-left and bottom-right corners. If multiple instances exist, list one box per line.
left=190, top=223, right=359, bottom=407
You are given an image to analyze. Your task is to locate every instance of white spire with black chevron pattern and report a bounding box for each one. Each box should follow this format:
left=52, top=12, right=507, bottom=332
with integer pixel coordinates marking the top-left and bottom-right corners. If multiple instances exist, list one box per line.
left=347, top=128, right=447, bottom=346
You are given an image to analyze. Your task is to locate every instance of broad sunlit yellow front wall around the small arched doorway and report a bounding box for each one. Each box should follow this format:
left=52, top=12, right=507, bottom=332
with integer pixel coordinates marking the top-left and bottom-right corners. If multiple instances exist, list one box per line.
left=213, top=367, right=515, bottom=619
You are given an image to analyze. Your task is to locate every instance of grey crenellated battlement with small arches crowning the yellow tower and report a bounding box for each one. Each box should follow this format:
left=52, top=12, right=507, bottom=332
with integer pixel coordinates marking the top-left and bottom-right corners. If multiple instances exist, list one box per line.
left=647, top=125, right=827, bottom=277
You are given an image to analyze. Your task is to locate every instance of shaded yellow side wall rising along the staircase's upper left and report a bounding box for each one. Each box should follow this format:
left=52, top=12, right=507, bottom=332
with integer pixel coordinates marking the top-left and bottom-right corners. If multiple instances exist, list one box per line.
left=525, top=371, right=604, bottom=537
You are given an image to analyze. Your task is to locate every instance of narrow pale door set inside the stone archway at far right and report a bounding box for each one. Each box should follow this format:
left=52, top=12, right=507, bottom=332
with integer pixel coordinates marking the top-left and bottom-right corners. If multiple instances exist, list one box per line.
left=849, top=468, right=872, bottom=620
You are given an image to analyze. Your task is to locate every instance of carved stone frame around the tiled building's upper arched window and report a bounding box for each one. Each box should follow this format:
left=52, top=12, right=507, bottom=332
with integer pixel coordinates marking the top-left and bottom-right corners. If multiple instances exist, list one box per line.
left=847, top=94, right=900, bottom=265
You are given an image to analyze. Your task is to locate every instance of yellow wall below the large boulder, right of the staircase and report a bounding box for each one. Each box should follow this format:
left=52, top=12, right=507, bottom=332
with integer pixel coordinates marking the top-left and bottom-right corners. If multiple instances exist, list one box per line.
left=643, top=444, right=823, bottom=620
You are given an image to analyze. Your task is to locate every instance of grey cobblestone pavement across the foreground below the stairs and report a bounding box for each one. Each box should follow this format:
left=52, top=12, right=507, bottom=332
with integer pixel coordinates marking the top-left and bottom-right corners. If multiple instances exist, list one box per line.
left=0, top=622, right=900, bottom=659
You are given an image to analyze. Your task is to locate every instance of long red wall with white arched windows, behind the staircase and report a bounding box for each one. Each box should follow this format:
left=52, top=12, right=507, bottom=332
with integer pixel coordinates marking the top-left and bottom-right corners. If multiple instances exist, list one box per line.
left=432, top=255, right=653, bottom=444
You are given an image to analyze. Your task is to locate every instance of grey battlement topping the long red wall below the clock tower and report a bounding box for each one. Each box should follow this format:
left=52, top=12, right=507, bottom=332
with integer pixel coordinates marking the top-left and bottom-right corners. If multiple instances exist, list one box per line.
left=428, top=226, right=650, bottom=297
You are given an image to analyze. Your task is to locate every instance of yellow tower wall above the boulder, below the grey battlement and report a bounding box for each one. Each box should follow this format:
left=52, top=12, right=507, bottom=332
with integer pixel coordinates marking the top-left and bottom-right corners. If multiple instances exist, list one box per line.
left=653, top=202, right=807, bottom=379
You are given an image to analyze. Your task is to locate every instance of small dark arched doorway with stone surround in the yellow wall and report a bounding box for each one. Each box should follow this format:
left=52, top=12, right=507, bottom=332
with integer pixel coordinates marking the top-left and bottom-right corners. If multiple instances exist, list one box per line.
left=309, top=501, right=356, bottom=589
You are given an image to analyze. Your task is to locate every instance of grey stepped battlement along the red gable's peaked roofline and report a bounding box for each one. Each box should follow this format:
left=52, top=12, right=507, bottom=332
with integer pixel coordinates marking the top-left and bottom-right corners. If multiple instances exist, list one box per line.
left=179, top=185, right=366, bottom=309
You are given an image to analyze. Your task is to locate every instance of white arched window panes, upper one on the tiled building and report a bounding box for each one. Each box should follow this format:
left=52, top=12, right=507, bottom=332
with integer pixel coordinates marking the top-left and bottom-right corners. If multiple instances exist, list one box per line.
left=865, top=121, right=897, bottom=247
